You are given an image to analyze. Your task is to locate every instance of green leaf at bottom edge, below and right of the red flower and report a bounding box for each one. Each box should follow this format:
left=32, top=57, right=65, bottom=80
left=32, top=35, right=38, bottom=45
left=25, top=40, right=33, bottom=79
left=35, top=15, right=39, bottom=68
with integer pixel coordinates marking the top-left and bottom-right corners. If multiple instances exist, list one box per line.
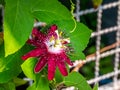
left=64, top=72, right=92, bottom=90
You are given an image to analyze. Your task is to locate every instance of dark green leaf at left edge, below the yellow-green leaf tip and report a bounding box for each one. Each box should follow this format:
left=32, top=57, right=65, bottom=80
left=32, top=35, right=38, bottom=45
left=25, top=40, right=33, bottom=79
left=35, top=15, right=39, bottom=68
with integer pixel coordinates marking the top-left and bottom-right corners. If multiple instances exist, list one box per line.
left=0, top=45, right=29, bottom=83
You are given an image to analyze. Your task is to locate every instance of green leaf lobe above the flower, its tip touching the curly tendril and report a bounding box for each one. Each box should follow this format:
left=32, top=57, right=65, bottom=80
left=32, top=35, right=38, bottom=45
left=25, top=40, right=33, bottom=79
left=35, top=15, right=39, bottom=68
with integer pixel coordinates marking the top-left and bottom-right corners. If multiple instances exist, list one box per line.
left=32, top=0, right=72, bottom=22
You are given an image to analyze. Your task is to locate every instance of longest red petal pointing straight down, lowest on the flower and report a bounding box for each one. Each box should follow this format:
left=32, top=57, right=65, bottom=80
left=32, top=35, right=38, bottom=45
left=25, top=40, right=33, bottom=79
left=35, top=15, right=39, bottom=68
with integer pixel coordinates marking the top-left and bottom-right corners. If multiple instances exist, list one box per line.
left=48, top=57, right=56, bottom=80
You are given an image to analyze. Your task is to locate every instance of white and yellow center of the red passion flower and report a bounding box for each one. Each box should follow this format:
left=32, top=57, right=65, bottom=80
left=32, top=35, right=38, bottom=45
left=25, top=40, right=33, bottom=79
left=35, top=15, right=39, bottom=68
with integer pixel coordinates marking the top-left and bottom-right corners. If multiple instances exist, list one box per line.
left=45, top=30, right=69, bottom=53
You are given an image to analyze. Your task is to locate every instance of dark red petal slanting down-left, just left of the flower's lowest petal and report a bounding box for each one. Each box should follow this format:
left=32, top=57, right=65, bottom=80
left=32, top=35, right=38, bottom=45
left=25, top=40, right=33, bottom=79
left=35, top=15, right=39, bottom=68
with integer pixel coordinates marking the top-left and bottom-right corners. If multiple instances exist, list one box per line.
left=34, top=57, right=47, bottom=73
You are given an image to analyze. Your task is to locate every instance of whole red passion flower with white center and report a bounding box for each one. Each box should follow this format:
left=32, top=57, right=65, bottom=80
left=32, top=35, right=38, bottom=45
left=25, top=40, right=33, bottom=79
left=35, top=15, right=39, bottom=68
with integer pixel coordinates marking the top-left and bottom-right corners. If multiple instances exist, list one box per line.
left=22, top=25, right=73, bottom=80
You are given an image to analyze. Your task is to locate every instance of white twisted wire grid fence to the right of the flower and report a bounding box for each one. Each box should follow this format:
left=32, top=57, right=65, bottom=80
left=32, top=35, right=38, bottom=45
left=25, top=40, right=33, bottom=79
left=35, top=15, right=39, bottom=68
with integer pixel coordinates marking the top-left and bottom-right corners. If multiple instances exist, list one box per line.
left=74, top=0, right=120, bottom=90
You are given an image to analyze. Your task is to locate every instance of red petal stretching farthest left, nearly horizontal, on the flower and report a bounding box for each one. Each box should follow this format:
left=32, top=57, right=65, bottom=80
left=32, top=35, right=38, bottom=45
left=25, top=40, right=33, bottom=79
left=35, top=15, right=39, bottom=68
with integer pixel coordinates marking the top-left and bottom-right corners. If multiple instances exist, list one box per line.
left=22, top=48, right=45, bottom=60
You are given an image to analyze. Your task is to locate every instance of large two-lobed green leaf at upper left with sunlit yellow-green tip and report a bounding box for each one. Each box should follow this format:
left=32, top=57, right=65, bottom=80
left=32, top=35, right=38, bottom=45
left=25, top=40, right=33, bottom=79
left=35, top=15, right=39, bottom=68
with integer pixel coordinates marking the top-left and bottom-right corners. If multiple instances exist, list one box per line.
left=4, top=0, right=72, bottom=56
